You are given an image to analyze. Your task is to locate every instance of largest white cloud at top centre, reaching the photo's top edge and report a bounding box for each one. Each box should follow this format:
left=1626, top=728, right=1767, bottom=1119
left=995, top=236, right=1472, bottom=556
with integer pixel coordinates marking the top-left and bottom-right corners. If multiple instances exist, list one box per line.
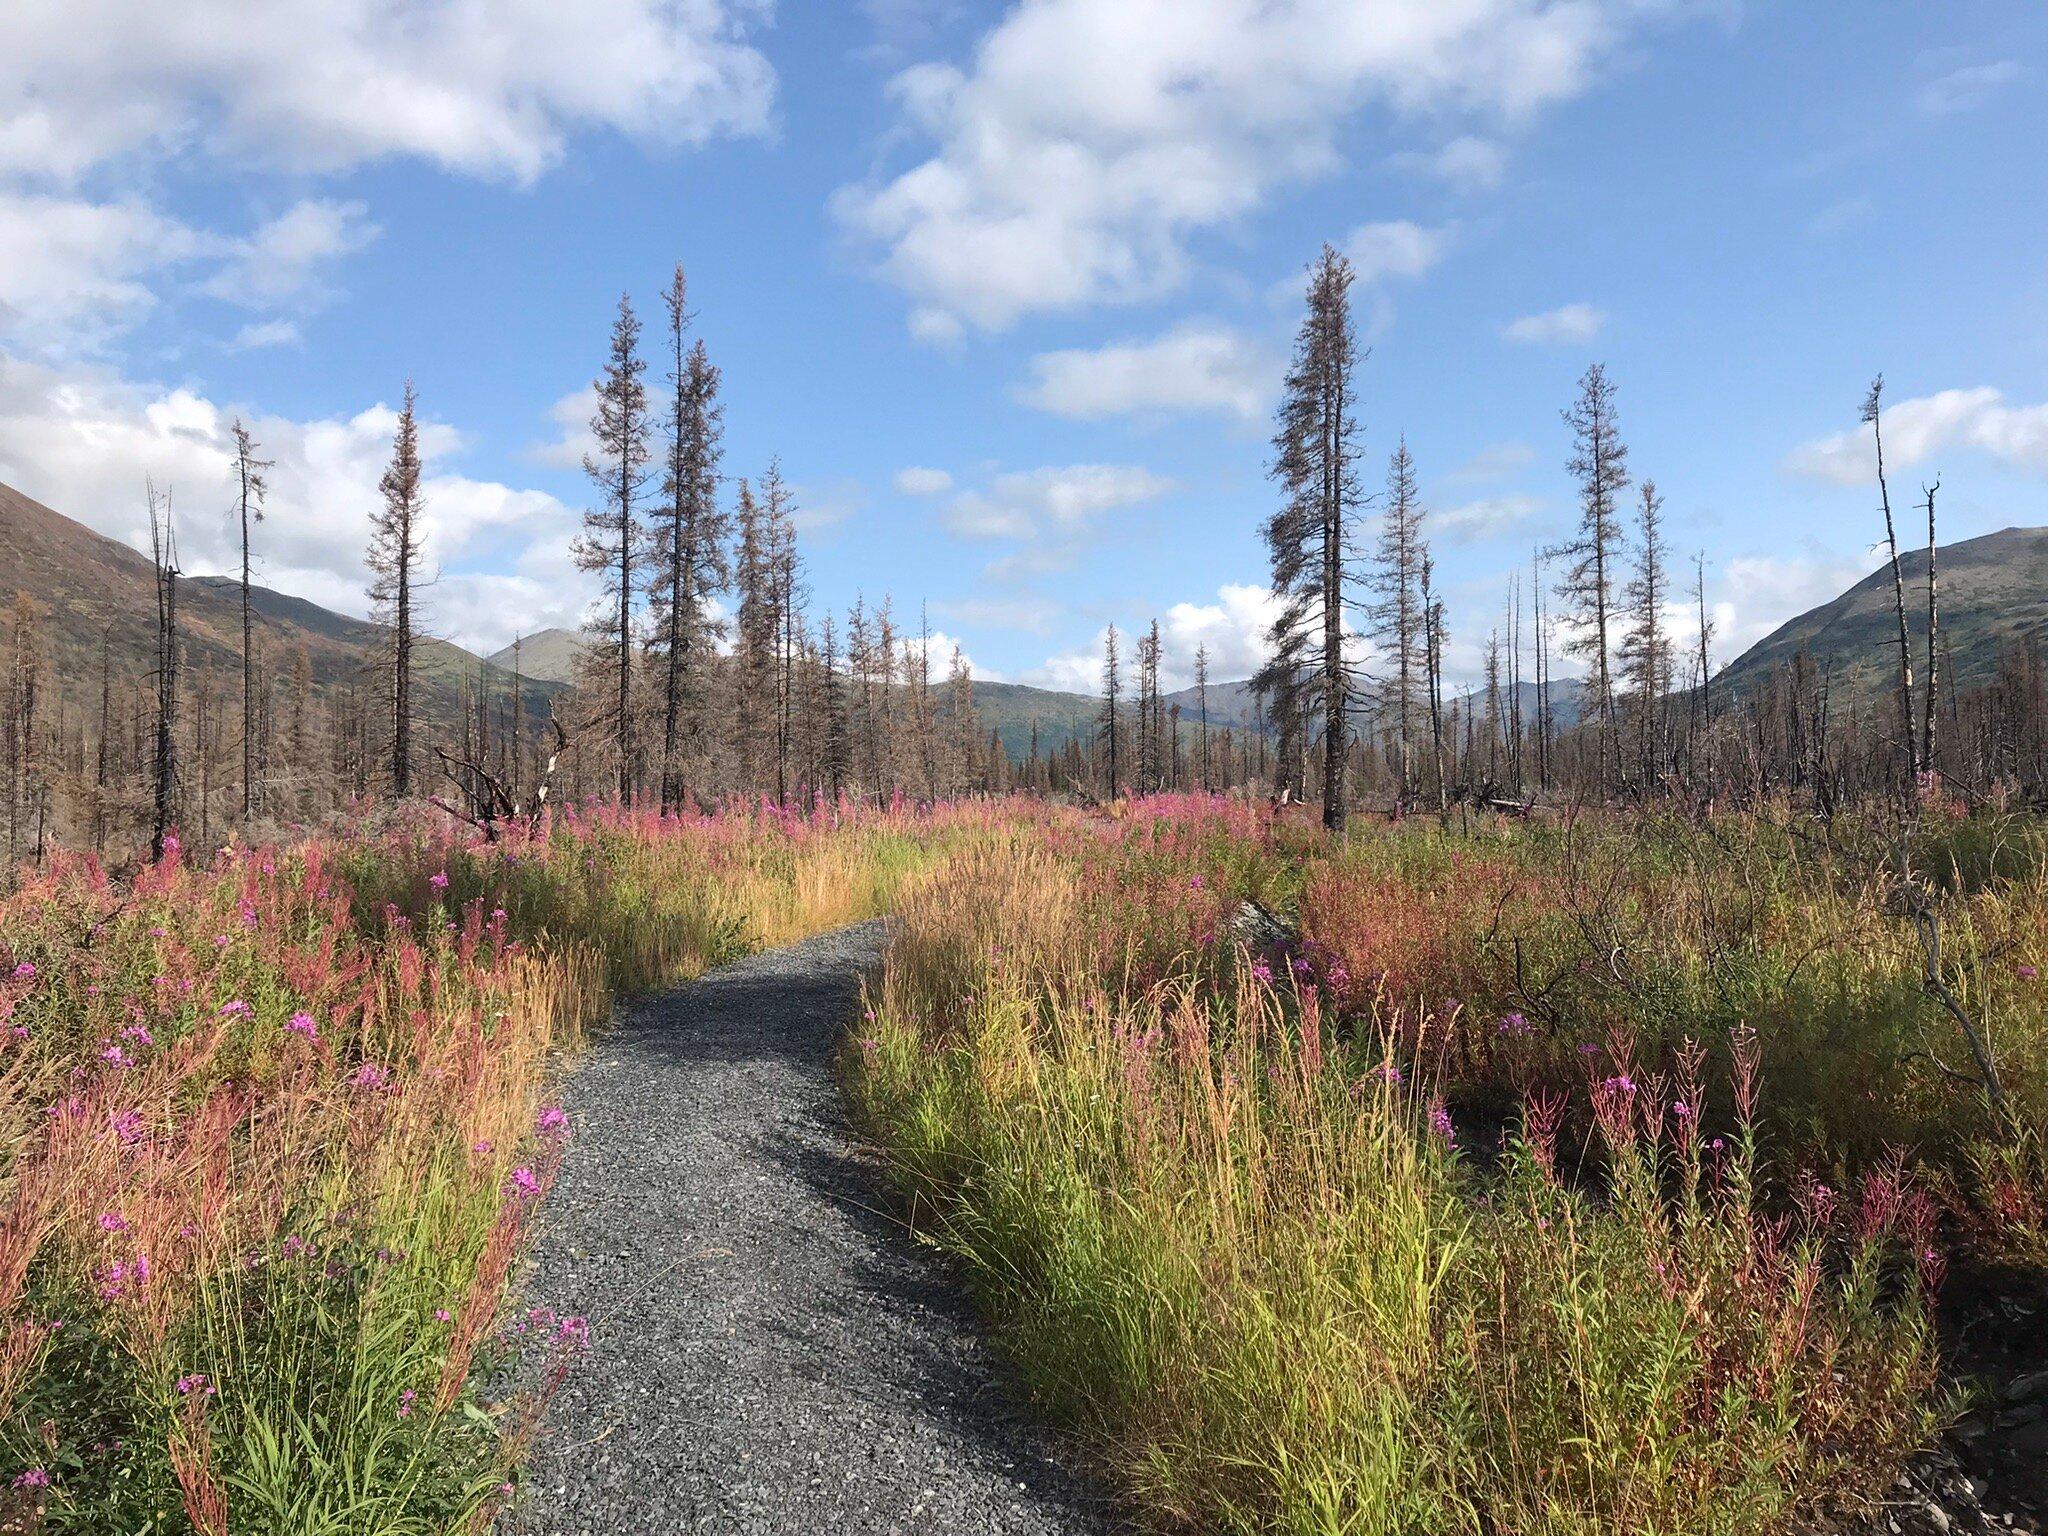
left=834, top=0, right=1661, bottom=338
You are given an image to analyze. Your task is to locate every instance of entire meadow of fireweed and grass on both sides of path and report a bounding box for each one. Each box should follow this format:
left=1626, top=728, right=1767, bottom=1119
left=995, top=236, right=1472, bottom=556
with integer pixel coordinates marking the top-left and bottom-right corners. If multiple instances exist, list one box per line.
left=0, top=797, right=2048, bottom=1536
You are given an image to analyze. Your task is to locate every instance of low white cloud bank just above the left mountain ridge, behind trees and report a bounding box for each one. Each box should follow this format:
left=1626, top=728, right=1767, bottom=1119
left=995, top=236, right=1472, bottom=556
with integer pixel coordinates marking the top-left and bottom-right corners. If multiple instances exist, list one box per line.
left=0, top=352, right=588, bottom=645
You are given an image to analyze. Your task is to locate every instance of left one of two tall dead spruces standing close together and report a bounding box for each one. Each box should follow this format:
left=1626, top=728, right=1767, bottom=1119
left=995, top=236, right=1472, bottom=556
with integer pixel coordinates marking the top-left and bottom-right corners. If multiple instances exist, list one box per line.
left=575, top=295, right=649, bottom=803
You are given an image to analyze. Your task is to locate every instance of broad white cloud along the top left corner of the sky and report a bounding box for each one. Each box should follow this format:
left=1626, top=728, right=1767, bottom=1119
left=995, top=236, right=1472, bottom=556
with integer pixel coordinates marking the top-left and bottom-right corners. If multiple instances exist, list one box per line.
left=0, top=0, right=774, bottom=180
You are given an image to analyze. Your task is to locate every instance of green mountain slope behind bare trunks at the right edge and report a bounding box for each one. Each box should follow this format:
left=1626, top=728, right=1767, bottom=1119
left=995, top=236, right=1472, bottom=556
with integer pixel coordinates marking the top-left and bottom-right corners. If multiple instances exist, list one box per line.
left=1716, top=528, right=2048, bottom=694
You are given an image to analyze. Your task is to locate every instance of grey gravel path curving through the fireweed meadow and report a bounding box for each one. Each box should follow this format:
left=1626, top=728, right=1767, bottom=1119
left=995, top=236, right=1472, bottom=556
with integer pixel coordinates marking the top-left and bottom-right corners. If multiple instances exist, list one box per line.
left=516, top=922, right=1108, bottom=1536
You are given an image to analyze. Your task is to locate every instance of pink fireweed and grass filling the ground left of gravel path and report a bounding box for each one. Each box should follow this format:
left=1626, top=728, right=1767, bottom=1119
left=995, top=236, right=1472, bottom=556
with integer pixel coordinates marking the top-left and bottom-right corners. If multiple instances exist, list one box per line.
left=0, top=807, right=946, bottom=1536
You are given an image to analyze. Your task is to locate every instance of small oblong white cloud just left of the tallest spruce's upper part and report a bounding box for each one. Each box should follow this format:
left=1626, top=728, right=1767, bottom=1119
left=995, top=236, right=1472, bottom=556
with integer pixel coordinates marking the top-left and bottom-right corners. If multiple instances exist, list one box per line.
left=1016, top=322, right=1280, bottom=422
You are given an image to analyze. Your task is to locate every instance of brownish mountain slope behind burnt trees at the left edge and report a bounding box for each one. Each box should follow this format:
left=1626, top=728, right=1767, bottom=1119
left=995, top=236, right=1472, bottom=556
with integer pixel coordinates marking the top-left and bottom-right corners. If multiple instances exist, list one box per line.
left=0, top=485, right=561, bottom=733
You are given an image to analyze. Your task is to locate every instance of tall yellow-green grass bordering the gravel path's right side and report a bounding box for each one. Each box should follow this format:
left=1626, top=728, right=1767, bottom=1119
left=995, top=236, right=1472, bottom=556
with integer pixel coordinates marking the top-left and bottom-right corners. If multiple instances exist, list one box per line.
left=846, top=831, right=1939, bottom=1536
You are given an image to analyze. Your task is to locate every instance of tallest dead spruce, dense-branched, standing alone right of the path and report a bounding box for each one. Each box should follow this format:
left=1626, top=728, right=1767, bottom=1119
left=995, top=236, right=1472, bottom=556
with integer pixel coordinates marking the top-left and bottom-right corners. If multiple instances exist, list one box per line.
left=1260, top=246, right=1360, bottom=829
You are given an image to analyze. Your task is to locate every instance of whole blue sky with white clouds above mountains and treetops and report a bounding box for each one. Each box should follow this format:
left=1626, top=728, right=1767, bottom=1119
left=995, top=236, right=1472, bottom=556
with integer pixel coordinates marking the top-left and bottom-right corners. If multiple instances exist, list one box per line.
left=0, top=0, right=2048, bottom=686
